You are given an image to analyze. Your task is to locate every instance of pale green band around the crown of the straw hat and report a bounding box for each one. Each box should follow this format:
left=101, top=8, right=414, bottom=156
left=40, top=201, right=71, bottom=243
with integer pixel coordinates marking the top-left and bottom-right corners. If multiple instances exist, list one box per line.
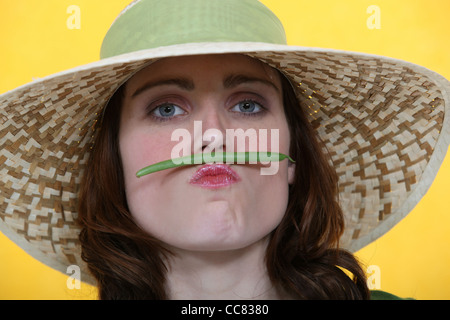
left=100, top=0, right=286, bottom=59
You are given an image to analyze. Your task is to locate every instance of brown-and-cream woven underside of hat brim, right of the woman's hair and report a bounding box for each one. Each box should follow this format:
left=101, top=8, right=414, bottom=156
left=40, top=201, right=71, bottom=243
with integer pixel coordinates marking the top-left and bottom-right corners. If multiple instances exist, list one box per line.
left=250, top=53, right=450, bottom=251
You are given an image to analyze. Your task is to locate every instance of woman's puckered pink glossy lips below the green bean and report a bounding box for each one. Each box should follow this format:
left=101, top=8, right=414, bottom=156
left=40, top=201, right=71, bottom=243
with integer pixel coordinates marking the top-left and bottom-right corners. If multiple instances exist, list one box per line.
left=189, top=164, right=240, bottom=189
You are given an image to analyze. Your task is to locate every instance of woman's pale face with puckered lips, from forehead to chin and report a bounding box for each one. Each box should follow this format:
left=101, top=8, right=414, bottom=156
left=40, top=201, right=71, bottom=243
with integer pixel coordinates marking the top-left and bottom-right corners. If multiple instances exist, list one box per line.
left=119, top=55, right=293, bottom=251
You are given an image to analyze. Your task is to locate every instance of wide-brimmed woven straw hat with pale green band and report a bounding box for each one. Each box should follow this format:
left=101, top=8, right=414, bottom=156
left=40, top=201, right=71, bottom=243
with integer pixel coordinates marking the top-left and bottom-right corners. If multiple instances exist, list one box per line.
left=0, top=0, right=450, bottom=283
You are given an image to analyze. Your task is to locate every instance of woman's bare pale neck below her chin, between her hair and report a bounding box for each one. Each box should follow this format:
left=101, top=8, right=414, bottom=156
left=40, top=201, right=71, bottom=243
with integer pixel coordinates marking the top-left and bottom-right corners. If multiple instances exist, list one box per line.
left=166, top=239, right=281, bottom=300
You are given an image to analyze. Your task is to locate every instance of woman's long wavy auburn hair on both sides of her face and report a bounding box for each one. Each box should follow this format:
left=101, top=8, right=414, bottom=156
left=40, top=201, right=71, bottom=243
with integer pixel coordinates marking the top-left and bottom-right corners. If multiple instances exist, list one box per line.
left=78, top=64, right=369, bottom=299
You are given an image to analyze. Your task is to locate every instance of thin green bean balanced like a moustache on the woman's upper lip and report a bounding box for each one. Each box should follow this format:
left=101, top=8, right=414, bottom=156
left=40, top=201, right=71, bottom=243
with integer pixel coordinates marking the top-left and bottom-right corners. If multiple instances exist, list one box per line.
left=136, top=152, right=295, bottom=178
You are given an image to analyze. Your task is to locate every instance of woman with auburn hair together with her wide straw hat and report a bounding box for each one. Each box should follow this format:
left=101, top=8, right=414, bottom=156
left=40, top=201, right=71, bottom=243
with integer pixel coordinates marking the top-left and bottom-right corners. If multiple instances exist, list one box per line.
left=0, top=0, right=449, bottom=299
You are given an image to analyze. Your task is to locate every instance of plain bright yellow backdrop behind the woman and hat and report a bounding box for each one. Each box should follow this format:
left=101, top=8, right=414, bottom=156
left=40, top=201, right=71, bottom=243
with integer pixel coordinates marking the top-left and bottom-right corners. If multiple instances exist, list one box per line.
left=0, top=0, right=450, bottom=299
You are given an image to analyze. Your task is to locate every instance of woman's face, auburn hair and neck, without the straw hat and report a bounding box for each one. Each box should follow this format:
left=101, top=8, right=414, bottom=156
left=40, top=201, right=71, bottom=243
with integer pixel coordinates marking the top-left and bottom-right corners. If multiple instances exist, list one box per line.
left=79, top=55, right=368, bottom=299
